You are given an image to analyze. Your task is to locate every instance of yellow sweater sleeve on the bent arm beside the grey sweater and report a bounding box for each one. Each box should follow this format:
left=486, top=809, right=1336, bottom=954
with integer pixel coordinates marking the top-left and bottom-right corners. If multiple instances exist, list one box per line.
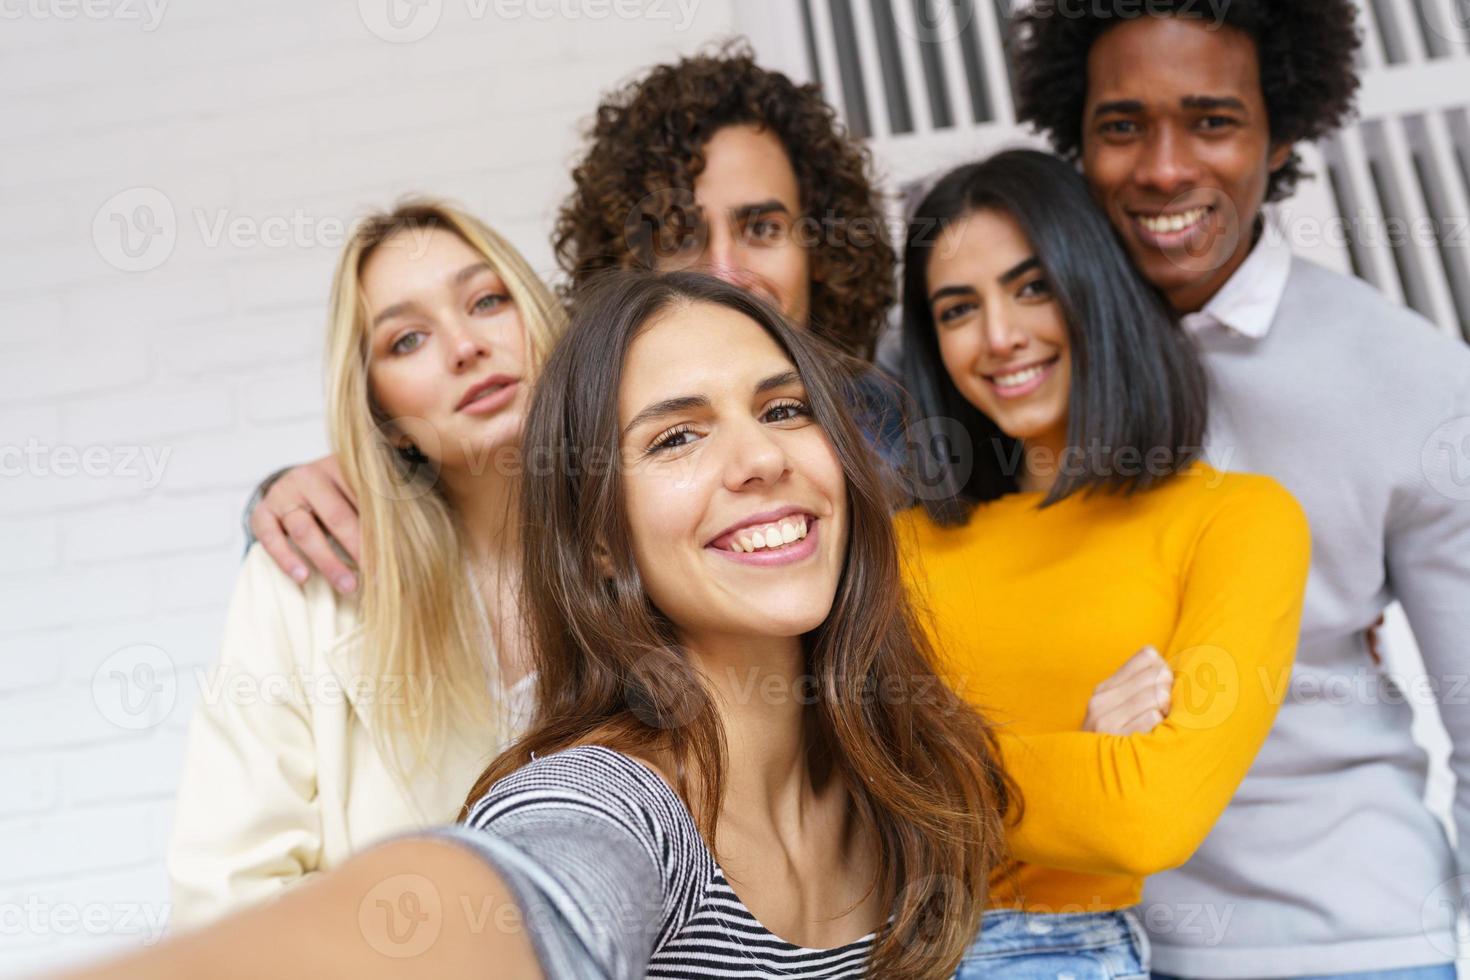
left=1000, top=478, right=1311, bottom=876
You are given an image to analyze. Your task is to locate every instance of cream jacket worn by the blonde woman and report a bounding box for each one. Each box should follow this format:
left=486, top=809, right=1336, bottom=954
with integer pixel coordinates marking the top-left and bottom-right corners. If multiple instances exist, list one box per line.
left=168, top=544, right=531, bottom=929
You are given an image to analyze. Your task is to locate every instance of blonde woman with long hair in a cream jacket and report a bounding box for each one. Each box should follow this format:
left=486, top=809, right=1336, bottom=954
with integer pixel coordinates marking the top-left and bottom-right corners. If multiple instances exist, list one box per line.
left=168, top=201, right=564, bottom=926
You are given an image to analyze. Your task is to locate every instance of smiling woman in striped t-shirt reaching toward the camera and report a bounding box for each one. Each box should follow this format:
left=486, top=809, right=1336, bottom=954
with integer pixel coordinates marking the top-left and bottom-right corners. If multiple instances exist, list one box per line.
left=80, top=273, right=1016, bottom=980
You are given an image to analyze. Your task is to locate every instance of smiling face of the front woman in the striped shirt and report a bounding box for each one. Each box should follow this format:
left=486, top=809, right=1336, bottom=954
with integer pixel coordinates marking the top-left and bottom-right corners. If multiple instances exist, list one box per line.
left=617, top=303, right=848, bottom=646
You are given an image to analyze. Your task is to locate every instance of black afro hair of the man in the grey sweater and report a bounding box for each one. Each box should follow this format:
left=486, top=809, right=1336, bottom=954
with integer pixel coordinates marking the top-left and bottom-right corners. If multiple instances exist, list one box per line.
left=1011, top=0, right=1360, bottom=201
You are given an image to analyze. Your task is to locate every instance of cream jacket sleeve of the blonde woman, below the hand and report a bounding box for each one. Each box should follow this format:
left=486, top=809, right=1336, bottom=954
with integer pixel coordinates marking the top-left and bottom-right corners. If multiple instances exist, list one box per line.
left=168, top=547, right=322, bottom=926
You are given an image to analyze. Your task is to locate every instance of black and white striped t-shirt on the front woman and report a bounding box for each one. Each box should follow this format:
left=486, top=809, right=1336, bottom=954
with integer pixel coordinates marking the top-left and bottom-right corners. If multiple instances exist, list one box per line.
left=428, top=745, right=875, bottom=980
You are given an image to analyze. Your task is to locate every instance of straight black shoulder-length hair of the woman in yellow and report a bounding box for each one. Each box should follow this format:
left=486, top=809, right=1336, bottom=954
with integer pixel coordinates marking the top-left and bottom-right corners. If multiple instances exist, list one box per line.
left=903, top=150, right=1207, bottom=525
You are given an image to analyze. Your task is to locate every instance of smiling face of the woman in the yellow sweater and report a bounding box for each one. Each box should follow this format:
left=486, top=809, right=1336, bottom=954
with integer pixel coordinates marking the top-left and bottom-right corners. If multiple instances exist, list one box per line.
left=928, top=210, right=1072, bottom=442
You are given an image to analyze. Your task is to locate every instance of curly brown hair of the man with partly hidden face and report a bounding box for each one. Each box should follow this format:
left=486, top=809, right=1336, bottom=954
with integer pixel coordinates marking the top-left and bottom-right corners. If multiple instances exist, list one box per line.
left=553, top=41, right=897, bottom=359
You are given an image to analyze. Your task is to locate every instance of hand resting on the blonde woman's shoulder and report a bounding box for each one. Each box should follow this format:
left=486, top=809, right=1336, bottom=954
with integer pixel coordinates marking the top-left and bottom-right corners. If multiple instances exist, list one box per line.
left=250, top=455, right=362, bottom=594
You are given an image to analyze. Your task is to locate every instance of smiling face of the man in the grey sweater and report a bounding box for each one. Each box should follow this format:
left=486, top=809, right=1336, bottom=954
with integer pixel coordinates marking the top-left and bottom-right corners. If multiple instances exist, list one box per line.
left=1082, top=16, right=1291, bottom=313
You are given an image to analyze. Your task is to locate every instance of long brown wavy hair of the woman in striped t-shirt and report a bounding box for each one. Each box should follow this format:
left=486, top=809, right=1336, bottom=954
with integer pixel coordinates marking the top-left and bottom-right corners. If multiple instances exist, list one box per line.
left=466, top=272, right=1017, bottom=977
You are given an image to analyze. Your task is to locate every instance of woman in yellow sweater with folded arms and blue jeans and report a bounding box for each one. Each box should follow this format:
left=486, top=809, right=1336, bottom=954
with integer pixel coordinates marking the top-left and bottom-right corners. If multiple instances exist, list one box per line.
left=898, top=150, right=1310, bottom=980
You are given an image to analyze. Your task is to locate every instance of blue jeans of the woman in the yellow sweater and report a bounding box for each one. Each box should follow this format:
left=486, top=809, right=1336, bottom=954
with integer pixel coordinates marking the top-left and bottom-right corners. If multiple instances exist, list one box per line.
left=954, top=909, right=1148, bottom=980
